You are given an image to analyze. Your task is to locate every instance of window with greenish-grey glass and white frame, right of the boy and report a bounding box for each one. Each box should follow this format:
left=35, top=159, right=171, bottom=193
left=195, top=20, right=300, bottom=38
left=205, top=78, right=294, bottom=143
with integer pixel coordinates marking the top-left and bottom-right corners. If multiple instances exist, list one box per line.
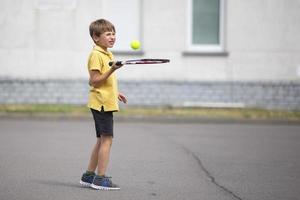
left=187, top=0, right=225, bottom=53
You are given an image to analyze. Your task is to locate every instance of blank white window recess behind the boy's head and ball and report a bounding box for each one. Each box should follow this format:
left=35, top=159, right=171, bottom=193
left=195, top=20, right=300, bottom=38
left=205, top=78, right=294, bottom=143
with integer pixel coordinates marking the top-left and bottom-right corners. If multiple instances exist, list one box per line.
left=103, top=0, right=142, bottom=53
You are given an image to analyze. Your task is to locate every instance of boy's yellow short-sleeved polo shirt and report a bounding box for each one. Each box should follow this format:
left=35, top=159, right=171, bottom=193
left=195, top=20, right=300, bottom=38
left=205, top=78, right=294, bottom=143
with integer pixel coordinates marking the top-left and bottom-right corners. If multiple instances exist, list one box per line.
left=88, top=46, right=119, bottom=111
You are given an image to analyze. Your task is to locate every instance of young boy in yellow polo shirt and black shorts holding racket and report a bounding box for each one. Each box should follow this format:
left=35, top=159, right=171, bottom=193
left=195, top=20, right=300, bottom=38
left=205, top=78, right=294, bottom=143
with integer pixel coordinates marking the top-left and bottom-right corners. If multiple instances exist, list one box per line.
left=80, top=19, right=127, bottom=190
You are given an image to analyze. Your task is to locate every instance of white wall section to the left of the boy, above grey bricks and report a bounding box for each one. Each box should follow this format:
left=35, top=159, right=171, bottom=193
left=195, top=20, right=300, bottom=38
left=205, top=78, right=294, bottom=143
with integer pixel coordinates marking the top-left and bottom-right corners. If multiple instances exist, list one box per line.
left=0, top=0, right=97, bottom=78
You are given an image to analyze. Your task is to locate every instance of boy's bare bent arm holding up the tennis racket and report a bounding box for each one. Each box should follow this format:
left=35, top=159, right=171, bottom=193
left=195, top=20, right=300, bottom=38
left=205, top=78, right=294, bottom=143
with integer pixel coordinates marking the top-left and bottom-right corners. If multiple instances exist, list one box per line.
left=89, top=62, right=122, bottom=87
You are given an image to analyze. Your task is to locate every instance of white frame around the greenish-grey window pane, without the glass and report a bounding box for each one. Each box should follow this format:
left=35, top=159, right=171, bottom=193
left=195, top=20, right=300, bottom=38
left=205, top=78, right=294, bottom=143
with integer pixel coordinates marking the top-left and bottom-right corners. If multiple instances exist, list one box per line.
left=185, top=0, right=226, bottom=54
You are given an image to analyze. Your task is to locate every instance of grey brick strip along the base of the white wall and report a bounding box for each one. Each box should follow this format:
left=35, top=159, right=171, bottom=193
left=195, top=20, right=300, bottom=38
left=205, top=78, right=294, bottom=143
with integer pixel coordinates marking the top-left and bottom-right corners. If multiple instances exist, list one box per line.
left=0, top=78, right=300, bottom=110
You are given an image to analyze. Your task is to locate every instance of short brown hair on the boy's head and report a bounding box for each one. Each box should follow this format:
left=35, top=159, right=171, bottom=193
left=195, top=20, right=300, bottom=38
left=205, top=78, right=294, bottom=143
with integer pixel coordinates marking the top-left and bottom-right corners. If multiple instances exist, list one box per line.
left=89, top=19, right=116, bottom=38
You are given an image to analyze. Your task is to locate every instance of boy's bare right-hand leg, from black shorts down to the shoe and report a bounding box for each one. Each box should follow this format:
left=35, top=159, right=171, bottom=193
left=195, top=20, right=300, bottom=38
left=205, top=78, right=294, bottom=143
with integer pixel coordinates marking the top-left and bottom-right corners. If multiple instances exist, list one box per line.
left=97, top=135, right=112, bottom=176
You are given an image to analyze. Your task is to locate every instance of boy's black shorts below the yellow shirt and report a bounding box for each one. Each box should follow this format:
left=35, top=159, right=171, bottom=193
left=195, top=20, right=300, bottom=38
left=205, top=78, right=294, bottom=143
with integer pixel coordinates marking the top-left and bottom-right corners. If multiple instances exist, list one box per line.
left=91, top=109, right=114, bottom=138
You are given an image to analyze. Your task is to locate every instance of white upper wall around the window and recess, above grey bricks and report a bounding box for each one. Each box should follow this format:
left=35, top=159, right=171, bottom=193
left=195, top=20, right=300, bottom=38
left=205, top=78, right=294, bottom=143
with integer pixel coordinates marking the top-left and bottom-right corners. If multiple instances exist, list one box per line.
left=0, top=0, right=300, bottom=81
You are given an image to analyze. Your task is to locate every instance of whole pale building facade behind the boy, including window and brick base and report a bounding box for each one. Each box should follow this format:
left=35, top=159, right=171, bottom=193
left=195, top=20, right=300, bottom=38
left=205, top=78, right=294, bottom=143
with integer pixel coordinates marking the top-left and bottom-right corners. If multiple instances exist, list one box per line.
left=0, top=0, right=300, bottom=109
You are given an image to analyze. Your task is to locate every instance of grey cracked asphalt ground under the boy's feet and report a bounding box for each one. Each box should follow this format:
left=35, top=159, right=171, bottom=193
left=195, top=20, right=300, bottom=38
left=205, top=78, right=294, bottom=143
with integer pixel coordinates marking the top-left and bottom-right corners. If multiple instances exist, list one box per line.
left=0, top=118, right=300, bottom=200
